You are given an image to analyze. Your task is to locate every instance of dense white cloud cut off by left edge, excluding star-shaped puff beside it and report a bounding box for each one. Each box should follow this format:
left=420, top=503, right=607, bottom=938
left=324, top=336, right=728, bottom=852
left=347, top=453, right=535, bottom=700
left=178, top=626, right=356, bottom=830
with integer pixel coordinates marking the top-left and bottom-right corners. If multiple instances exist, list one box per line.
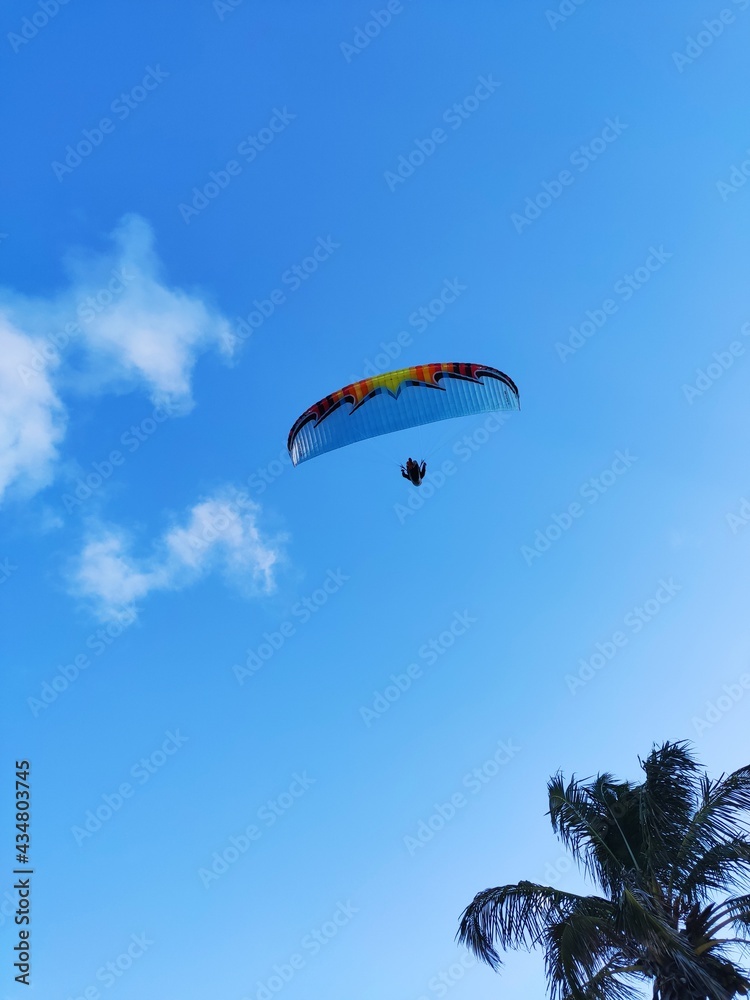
left=0, top=312, right=65, bottom=497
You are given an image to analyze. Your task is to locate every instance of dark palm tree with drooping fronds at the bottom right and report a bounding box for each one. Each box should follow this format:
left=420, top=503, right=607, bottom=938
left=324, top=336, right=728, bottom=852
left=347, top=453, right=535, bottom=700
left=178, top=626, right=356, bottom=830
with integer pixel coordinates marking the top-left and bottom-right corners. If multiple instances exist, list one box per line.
left=458, top=743, right=750, bottom=1000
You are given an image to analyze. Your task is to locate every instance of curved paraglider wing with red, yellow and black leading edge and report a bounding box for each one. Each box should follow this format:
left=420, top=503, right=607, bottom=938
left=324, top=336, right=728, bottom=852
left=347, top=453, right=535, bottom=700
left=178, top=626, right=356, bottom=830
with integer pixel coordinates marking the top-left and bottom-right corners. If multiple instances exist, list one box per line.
left=288, top=363, right=519, bottom=465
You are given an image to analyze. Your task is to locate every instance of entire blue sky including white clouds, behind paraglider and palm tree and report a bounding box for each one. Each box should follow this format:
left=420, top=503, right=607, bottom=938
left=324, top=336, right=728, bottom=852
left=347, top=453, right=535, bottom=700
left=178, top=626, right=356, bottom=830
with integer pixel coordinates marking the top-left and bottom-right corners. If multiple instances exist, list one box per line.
left=0, top=0, right=750, bottom=1000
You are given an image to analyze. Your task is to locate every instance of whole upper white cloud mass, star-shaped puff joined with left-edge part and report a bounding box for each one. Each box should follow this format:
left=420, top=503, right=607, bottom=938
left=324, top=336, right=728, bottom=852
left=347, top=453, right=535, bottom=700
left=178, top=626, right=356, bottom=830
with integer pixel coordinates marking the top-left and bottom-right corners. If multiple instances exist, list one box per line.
left=0, top=216, right=232, bottom=499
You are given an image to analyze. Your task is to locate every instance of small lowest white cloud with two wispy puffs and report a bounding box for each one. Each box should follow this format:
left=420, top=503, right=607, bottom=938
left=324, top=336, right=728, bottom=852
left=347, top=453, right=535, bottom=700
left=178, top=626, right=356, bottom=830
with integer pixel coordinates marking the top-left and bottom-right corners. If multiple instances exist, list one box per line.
left=73, top=489, right=284, bottom=620
